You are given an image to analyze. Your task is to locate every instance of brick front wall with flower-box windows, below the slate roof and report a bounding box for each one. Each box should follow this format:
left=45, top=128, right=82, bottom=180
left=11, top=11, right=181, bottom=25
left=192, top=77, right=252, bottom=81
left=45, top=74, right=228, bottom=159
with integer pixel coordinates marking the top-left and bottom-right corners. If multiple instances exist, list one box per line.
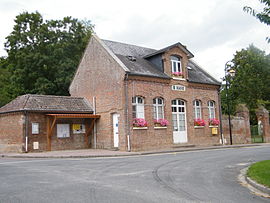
left=128, top=78, right=220, bottom=151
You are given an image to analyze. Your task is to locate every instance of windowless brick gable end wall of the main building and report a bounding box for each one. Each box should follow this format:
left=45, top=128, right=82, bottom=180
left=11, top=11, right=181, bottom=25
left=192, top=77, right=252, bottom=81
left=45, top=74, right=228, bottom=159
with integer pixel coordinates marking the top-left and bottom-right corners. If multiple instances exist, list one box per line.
left=70, top=37, right=126, bottom=150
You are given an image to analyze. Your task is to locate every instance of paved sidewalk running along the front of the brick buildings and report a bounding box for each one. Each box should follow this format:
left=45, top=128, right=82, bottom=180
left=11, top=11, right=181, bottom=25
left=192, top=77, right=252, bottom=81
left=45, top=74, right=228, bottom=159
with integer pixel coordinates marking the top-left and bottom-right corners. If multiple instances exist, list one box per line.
left=0, top=143, right=270, bottom=158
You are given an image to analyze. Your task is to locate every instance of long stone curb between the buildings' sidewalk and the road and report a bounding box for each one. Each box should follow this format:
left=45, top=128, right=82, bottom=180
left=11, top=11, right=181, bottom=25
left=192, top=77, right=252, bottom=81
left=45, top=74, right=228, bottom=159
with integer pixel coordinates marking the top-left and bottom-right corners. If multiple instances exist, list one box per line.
left=0, top=144, right=262, bottom=159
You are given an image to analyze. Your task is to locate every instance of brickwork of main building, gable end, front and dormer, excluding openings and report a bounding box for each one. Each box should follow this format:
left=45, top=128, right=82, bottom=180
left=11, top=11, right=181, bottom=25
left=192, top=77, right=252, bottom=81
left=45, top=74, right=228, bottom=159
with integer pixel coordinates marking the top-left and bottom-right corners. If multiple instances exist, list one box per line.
left=70, top=37, right=224, bottom=151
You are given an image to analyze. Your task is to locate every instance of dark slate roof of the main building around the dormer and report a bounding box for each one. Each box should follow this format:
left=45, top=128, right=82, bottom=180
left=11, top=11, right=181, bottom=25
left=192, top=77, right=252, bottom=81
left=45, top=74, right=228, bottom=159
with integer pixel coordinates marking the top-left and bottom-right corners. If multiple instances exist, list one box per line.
left=102, top=40, right=220, bottom=85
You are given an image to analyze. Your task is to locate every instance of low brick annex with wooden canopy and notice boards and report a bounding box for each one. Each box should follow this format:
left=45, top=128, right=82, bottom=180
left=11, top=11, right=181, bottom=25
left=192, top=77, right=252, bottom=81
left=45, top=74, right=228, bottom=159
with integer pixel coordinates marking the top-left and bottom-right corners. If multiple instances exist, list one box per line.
left=0, top=94, right=99, bottom=152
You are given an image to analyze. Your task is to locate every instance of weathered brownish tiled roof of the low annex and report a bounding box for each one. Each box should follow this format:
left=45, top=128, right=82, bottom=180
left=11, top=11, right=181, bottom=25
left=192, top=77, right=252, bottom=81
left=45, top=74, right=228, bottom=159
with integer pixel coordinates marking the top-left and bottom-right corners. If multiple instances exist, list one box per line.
left=0, top=94, right=93, bottom=113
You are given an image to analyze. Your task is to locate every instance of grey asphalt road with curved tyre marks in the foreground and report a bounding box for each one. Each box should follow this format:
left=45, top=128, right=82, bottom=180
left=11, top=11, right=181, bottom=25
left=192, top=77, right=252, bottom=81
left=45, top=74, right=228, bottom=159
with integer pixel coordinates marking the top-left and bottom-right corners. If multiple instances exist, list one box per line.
left=0, top=146, right=270, bottom=203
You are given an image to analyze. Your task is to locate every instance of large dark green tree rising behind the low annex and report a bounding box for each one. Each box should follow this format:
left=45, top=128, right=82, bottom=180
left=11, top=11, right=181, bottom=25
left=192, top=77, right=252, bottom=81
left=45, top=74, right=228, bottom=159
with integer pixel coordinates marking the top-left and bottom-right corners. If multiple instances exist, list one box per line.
left=2, top=12, right=93, bottom=98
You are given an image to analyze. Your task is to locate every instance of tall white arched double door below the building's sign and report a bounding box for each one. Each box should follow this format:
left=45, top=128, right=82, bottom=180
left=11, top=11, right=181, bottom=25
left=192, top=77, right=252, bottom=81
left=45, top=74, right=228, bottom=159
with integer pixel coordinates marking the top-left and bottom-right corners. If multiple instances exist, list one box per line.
left=172, top=99, right=187, bottom=144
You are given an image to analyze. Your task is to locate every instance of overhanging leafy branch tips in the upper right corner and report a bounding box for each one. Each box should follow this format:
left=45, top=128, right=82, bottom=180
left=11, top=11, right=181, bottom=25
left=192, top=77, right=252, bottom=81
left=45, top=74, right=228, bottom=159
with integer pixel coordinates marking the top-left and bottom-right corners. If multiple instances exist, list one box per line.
left=243, top=0, right=270, bottom=43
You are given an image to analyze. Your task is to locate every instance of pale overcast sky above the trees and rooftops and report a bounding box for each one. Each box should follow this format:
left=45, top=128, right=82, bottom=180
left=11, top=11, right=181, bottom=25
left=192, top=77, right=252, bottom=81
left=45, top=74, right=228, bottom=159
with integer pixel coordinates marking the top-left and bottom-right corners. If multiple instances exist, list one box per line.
left=0, top=0, right=270, bottom=79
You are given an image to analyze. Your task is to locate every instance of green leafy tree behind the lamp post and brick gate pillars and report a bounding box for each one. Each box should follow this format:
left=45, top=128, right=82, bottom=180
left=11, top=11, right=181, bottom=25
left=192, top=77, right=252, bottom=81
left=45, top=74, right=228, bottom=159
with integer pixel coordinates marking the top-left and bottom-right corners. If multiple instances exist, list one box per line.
left=221, top=45, right=270, bottom=123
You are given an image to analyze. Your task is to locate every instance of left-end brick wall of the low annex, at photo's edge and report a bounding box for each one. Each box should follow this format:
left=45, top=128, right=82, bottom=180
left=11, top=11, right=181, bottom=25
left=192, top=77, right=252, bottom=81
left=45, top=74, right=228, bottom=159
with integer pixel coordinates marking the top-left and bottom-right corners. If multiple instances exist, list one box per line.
left=0, top=113, right=25, bottom=152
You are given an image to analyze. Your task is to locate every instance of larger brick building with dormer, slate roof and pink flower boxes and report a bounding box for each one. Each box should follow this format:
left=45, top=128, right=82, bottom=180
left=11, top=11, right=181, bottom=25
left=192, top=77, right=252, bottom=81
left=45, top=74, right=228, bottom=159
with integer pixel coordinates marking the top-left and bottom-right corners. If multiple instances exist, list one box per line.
left=70, top=36, right=220, bottom=151
